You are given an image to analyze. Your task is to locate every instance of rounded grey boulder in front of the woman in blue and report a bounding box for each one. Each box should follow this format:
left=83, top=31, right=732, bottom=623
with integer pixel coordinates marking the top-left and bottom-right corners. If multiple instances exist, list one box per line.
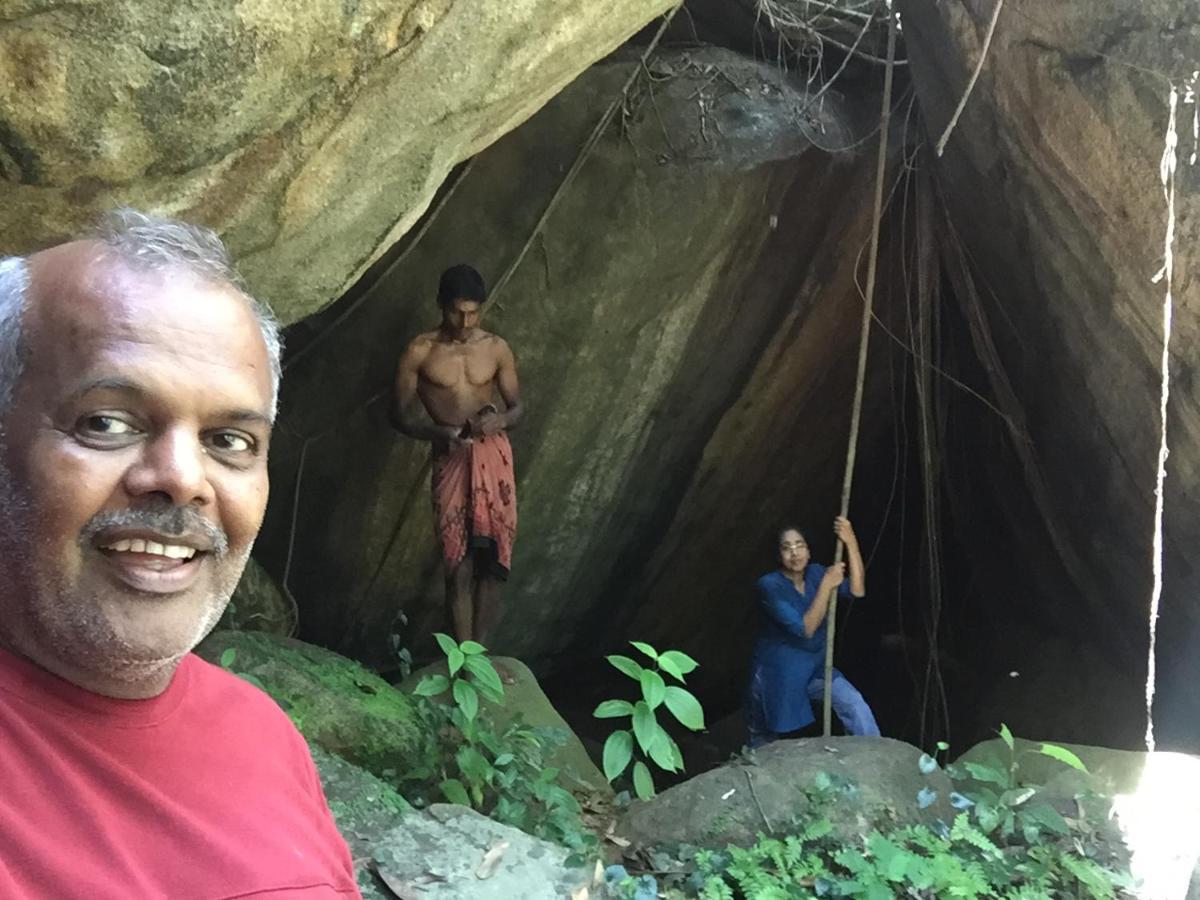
left=622, top=737, right=954, bottom=847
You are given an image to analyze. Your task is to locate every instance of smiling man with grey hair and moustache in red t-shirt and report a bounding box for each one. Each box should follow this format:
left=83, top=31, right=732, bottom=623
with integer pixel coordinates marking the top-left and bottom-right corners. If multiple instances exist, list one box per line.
left=0, top=211, right=358, bottom=900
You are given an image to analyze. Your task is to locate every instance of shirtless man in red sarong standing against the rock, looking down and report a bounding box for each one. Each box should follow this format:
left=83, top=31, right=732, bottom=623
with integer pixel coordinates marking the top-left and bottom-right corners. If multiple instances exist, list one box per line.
left=392, top=265, right=524, bottom=657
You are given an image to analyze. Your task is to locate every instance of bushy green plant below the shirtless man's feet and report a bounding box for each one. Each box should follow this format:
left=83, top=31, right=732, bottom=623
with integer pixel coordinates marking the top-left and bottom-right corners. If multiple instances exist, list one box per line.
left=400, top=634, right=599, bottom=858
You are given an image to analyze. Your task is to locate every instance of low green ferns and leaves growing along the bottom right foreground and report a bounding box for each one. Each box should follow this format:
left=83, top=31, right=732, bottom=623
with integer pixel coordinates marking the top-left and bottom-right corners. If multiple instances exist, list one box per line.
left=689, top=726, right=1134, bottom=900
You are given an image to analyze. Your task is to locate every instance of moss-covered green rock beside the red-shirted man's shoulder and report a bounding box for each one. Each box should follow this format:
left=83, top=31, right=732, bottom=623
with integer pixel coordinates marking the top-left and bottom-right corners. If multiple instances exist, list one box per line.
left=197, top=631, right=419, bottom=779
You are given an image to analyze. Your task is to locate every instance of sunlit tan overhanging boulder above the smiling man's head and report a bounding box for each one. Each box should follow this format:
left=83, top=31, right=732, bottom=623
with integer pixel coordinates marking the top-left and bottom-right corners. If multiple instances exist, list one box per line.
left=0, top=0, right=673, bottom=322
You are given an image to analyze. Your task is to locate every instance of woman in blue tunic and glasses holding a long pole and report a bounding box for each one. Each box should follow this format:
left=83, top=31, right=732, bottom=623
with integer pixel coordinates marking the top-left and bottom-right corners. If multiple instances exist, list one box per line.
left=746, top=516, right=880, bottom=746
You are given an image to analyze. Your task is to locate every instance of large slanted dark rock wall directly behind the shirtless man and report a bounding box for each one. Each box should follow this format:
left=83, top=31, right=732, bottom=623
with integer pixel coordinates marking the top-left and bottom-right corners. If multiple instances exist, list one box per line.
left=257, top=48, right=894, bottom=700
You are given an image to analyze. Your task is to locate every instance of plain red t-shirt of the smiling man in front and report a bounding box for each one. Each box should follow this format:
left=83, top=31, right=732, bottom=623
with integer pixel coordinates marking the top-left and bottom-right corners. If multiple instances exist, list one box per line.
left=0, top=650, right=359, bottom=900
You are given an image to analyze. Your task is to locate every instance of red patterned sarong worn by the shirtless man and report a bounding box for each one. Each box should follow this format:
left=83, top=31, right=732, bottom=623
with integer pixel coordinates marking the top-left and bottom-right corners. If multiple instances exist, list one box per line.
left=430, top=432, right=517, bottom=578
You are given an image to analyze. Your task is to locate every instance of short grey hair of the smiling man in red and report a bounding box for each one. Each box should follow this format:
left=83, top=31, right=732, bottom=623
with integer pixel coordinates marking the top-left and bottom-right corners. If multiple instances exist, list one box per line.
left=0, top=209, right=283, bottom=419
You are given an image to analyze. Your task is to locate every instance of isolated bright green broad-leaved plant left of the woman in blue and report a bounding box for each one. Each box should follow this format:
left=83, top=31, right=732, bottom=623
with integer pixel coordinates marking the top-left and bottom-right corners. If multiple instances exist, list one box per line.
left=593, top=641, right=704, bottom=800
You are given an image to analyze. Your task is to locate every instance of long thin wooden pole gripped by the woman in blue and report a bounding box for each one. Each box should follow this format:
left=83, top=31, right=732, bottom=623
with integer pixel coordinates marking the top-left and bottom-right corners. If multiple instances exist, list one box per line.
left=823, top=3, right=896, bottom=737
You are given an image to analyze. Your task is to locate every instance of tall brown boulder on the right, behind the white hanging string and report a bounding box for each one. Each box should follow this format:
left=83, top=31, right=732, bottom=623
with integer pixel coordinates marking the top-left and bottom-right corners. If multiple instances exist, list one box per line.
left=899, top=0, right=1200, bottom=748
